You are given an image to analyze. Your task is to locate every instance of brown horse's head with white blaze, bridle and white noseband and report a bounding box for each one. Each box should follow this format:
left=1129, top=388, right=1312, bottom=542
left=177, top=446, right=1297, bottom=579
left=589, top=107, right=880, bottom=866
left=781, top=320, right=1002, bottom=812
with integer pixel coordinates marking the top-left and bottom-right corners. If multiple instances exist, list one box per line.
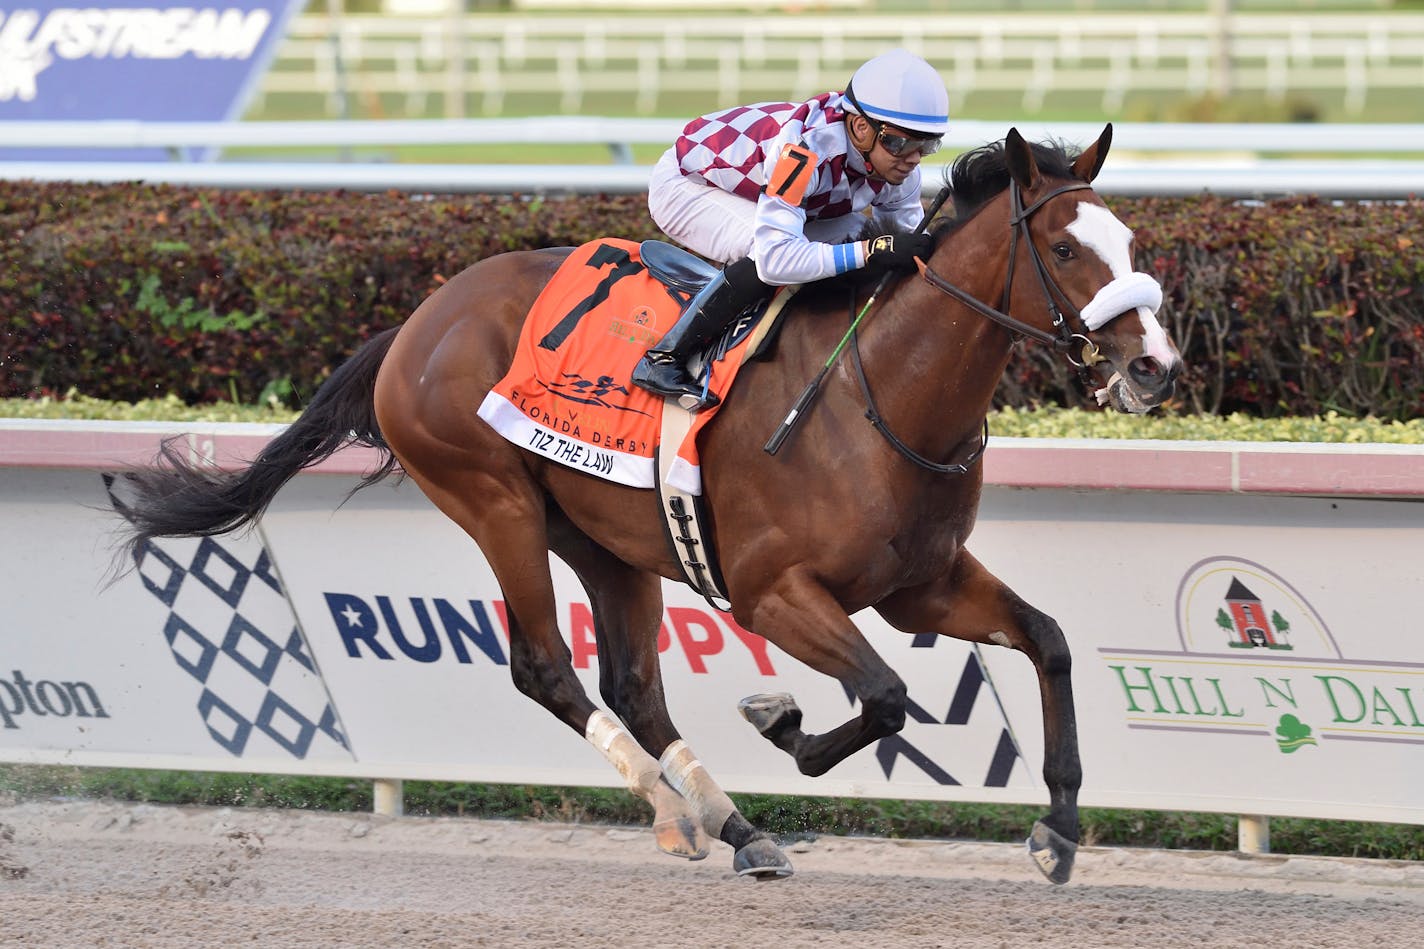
left=926, top=125, right=1182, bottom=412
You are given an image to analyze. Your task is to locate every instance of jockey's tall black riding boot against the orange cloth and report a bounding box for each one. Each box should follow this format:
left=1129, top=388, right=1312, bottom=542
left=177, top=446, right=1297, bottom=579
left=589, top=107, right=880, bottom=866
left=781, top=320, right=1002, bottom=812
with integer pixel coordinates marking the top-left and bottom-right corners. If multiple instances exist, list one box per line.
left=632, top=258, right=769, bottom=412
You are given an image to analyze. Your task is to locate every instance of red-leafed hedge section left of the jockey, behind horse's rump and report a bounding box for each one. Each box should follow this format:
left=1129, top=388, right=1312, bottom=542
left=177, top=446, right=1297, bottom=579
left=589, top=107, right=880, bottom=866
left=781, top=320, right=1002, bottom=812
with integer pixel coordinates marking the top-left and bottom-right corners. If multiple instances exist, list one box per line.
left=0, top=182, right=656, bottom=402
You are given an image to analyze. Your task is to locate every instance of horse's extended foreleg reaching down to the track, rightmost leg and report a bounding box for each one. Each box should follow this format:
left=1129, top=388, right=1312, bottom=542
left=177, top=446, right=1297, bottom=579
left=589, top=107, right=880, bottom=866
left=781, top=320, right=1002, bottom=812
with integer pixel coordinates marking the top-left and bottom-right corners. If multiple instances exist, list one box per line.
left=876, top=550, right=1082, bottom=883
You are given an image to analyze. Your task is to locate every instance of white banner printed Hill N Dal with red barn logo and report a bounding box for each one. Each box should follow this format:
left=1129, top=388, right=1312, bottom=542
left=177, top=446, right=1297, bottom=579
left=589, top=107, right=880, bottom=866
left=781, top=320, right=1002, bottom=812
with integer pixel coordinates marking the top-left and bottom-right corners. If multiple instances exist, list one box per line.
left=974, top=490, right=1424, bottom=822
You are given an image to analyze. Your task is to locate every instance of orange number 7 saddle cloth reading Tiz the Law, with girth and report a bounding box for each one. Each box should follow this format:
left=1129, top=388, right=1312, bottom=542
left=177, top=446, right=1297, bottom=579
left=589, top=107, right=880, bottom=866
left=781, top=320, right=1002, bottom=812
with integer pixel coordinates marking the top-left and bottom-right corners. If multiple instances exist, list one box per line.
left=478, top=238, right=793, bottom=608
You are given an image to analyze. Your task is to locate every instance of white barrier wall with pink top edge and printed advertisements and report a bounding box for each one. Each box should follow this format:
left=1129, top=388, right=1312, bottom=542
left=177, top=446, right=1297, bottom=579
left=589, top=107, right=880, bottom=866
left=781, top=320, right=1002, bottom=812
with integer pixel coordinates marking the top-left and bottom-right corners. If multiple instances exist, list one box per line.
left=0, top=422, right=1424, bottom=824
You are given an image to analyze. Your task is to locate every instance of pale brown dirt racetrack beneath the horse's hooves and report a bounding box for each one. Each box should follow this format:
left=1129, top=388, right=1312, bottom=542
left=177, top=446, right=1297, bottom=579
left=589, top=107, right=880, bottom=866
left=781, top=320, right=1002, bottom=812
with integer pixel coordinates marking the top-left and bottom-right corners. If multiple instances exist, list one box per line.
left=0, top=802, right=1424, bottom=949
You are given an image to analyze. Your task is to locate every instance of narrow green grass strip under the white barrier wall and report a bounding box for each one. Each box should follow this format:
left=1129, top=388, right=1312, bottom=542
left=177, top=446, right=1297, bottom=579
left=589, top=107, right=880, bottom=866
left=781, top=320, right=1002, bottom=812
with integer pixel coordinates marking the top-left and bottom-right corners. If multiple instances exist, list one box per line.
left=0, top=765, right=1424, bottom=861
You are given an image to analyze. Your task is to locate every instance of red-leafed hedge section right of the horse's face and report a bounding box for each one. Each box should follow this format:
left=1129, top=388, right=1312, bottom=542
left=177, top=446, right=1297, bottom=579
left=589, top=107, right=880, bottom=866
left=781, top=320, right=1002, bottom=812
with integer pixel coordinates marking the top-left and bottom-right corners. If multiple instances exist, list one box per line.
left=1000, top=195, right=1424, bottom=420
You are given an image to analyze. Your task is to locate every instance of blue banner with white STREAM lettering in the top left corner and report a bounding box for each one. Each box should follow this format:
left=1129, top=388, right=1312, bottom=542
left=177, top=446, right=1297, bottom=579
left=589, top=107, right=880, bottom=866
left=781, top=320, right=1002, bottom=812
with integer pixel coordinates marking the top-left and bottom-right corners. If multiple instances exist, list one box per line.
left=0, top=0, right=305, bottom=161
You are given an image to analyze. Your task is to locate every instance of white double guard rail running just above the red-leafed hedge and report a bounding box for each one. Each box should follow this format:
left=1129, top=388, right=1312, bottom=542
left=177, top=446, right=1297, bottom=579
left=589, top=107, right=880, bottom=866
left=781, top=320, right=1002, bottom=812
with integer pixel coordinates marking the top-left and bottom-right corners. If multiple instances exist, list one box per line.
left=0, top=115, right=1424, bottom=198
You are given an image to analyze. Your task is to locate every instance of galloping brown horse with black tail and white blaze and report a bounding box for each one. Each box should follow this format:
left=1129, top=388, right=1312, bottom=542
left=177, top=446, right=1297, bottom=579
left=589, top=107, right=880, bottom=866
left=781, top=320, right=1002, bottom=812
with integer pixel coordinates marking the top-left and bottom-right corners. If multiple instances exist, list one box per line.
left=113, top=125, right=1180, bottom=883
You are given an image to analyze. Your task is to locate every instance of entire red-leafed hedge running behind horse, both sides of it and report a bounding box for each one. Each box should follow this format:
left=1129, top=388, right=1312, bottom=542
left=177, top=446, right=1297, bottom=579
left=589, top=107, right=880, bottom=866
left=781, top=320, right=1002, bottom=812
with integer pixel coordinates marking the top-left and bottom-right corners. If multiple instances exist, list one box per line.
left=0, top=181, right=1424, bottom=420
